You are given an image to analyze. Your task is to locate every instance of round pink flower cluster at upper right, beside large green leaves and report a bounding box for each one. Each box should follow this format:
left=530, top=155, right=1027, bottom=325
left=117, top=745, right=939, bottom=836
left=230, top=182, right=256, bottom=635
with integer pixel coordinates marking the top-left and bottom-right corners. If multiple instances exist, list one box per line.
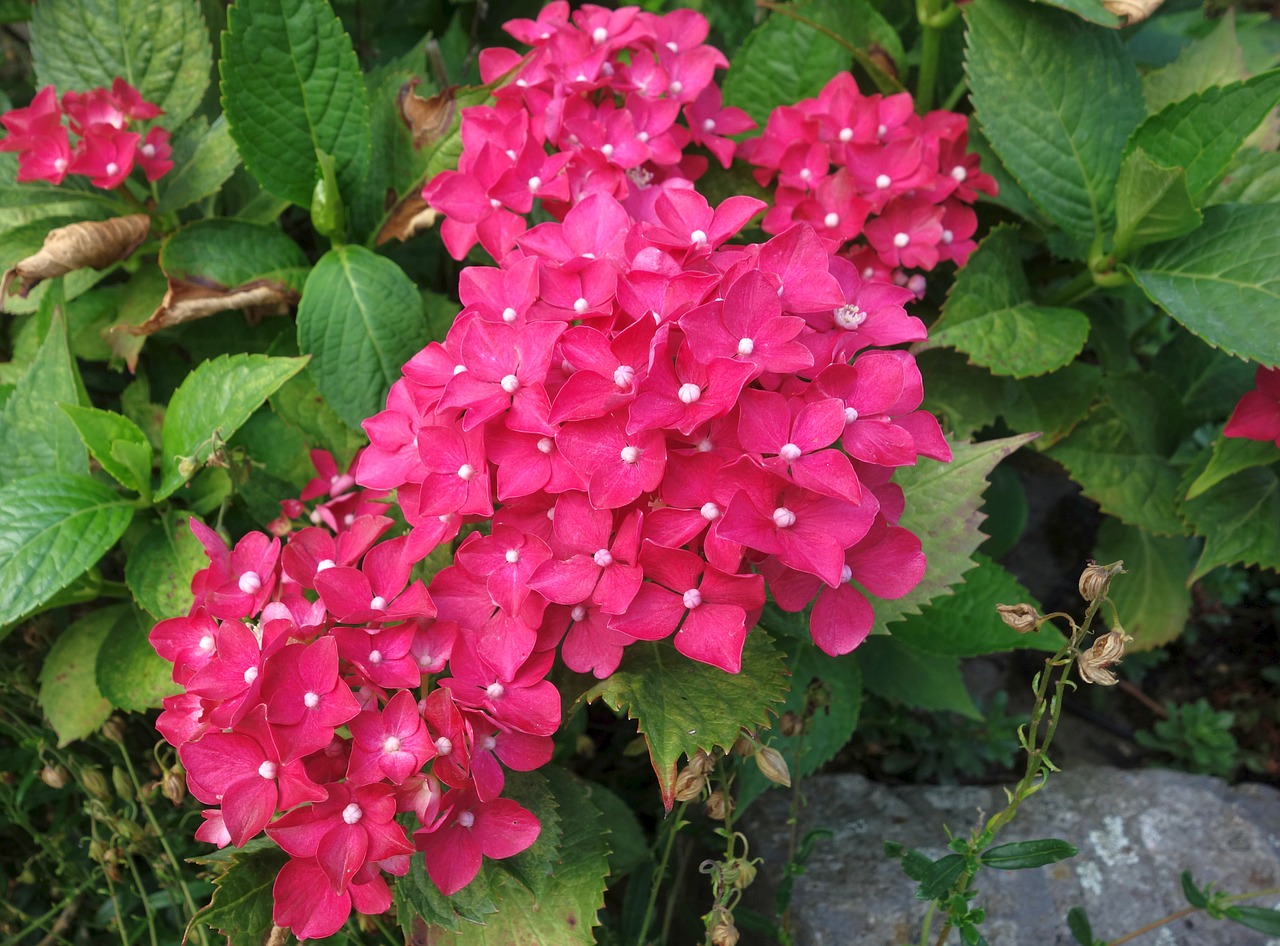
left=739, top=73, right=996, bottom=288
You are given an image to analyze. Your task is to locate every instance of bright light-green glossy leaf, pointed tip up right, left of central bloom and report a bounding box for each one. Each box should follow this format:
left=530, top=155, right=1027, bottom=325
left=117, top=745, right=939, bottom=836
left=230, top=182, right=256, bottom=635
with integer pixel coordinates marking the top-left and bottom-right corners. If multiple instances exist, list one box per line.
left=155, top=355, right=307, bottom=499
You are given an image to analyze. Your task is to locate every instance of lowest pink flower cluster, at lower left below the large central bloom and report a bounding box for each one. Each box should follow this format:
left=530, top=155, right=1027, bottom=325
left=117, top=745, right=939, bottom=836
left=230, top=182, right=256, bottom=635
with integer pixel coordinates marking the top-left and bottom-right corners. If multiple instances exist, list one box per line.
left=151, top=452, right=547, bottom=938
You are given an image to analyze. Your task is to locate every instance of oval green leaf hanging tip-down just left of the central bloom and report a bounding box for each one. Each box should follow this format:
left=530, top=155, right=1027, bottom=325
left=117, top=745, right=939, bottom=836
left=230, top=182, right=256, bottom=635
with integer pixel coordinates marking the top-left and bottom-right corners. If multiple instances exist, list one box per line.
left=298, top=246, right=428, bottom=428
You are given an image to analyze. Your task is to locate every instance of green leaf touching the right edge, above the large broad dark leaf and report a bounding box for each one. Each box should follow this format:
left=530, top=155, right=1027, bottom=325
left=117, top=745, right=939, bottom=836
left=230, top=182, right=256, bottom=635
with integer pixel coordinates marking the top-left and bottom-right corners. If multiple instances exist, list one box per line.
left=1126, top=69, right=1280, bottom=205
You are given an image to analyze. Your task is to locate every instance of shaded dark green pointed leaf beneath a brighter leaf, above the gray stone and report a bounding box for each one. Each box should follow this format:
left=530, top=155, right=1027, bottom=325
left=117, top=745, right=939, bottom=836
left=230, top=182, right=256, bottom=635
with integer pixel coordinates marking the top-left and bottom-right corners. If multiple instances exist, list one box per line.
left=854, top=635, right=982, bottom=719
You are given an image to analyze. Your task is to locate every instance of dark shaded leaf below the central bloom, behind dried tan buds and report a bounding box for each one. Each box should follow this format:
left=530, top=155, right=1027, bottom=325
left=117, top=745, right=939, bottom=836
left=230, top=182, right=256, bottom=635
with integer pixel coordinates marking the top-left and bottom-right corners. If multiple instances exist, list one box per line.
left=737, top=639, right=863, bottom=810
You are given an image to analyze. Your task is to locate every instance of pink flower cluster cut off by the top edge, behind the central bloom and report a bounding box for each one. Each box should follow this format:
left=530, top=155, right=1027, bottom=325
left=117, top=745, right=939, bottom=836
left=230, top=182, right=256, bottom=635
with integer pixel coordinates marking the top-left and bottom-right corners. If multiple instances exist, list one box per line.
left=422, top=0, right=755, bottom=260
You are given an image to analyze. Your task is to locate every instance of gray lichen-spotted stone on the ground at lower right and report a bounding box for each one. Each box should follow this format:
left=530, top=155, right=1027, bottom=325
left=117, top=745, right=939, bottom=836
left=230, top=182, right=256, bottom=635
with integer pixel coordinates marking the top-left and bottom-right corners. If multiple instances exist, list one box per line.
left=741, top=767, right=1280, bottom=946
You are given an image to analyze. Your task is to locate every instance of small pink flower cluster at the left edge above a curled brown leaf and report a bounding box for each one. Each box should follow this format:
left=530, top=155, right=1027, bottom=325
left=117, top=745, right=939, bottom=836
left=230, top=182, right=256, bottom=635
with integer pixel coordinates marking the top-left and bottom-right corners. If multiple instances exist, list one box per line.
left=0, top=78, right=173, bottom=189
